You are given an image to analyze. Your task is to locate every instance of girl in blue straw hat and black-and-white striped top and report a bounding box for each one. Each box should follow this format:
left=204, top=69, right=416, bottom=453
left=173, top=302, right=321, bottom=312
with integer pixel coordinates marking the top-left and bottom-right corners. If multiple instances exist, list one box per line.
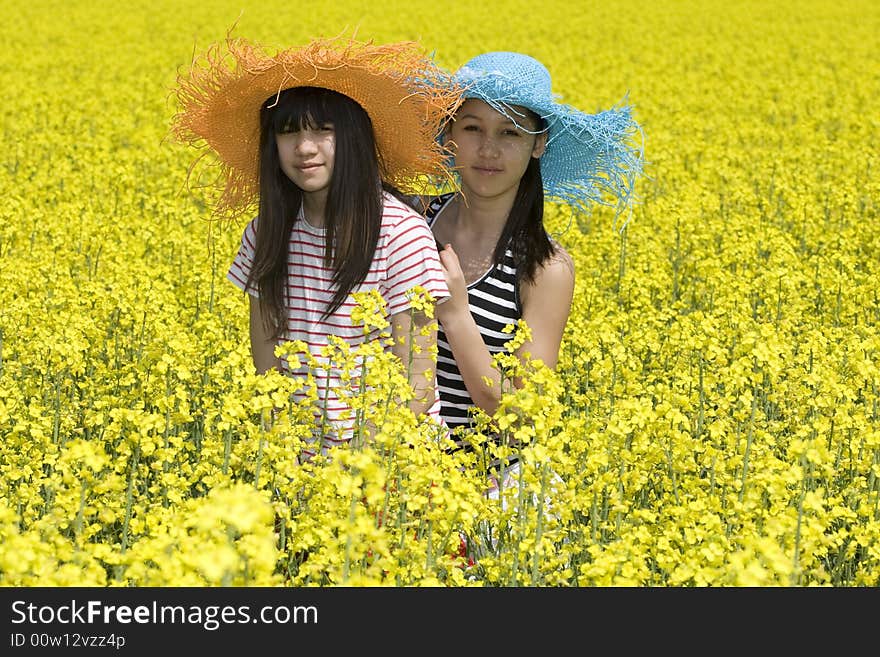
left=425, top=52, right=642, bottom=466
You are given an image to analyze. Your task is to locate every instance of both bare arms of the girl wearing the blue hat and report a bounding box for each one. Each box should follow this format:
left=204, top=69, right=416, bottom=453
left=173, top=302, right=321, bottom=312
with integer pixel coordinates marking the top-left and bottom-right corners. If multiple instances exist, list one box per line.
left=436, top=245, right=574, bottom=413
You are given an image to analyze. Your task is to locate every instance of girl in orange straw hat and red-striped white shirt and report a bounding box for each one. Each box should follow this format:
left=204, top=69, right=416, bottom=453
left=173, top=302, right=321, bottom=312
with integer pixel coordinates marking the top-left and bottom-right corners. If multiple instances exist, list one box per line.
left=175, top=39, right=458, bottom=458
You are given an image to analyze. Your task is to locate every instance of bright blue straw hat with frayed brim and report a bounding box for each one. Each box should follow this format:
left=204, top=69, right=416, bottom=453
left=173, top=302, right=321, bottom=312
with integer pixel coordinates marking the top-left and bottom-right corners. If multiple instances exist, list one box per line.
left=454, top=52, right=644, bottom=226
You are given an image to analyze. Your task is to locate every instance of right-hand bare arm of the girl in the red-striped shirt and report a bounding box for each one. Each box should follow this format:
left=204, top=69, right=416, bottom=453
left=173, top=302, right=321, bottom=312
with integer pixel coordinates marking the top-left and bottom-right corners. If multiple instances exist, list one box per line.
left=391, top=310, right=437, bottom=415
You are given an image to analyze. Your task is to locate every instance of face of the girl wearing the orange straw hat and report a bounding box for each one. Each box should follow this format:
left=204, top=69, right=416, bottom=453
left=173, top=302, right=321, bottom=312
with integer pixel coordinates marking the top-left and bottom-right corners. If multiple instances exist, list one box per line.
left=275, top=123, right=336, bottom=195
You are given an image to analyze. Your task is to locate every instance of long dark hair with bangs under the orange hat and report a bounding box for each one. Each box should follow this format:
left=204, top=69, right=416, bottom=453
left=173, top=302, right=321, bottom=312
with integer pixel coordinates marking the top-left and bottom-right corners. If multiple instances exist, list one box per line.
left=248, top=87, right=383, bottom=338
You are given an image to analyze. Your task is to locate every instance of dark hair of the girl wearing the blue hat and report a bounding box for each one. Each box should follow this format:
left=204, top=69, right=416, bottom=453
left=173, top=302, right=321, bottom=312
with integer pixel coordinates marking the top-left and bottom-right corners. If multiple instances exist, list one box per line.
left=492, top=108, right=556, bottom=283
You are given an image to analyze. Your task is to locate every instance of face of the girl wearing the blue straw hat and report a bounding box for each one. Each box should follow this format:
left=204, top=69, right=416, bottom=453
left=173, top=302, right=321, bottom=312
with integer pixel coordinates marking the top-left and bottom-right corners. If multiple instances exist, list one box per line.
left=447, top=98, right=547, bottom=197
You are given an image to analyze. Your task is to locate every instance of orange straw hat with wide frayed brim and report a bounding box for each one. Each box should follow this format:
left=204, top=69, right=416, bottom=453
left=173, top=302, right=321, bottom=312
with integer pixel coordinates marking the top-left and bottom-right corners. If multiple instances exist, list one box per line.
left=172, top=37, right=461, bottom=218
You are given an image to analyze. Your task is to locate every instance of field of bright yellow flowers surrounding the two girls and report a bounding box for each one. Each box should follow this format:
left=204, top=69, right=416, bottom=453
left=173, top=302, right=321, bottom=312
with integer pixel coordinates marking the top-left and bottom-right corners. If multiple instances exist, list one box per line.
left=0, top=0, right=880, bottom=587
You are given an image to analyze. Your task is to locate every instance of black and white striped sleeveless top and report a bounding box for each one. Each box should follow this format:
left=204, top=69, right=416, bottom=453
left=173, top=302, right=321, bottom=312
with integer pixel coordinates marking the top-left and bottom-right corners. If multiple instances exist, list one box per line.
left=425, top=193, right=522, bottom=440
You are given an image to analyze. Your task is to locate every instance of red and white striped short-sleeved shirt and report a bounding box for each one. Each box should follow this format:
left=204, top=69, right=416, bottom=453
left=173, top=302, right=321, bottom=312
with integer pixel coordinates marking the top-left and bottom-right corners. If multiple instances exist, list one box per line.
left=226, top=193, right=449, bottom=457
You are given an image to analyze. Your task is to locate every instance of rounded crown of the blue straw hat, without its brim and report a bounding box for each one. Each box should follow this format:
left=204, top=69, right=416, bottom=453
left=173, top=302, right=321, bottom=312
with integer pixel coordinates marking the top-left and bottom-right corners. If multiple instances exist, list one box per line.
left=455, top=52, right=553, bottom=113
